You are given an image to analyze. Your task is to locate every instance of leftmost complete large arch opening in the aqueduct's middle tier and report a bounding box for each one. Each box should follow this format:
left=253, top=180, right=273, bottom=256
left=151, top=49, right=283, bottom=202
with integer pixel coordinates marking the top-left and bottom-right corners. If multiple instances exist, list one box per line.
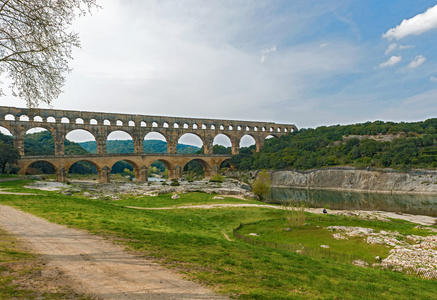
left=24, top=127, right=55, bottom=155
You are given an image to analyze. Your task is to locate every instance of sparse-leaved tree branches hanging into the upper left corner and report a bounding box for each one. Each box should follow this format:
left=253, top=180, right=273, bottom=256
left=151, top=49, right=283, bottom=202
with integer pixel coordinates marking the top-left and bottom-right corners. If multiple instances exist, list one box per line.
left=0, top=0, right=97, bottom=107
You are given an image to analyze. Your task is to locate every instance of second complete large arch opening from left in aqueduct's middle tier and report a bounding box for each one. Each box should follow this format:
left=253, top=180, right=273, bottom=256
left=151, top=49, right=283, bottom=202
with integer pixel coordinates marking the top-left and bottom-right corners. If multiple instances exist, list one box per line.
left=64, top=129, right=97, bottom=154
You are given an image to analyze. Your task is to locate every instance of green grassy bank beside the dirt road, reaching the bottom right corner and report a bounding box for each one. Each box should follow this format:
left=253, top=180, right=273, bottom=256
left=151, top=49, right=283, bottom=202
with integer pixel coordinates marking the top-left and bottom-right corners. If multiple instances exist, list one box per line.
left=0, top=182, right=436, bottom=299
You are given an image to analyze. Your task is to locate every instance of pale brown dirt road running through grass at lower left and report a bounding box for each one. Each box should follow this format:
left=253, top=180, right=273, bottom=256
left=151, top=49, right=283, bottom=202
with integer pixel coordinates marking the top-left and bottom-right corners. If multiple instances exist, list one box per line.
left=0, top=205, right=227, bottom=299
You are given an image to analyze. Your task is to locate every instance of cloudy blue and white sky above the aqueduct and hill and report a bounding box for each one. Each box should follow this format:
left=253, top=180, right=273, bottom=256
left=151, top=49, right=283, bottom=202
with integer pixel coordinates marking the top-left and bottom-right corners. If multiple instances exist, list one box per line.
left=0, top=0, right=437, bottom=143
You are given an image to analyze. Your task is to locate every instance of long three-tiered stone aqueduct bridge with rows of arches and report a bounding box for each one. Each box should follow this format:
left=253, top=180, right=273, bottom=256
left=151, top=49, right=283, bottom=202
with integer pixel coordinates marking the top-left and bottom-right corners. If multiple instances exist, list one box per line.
left=0, top=106, right=297, bottom=183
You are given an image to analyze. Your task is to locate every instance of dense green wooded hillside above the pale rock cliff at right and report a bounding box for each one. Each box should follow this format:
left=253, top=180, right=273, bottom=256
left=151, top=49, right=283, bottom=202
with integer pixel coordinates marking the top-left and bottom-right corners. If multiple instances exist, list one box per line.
left=231, top=119, right=437, bottom=170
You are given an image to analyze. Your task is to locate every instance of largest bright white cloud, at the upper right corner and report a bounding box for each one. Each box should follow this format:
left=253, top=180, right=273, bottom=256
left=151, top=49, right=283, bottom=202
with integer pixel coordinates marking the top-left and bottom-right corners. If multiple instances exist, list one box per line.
left=382, top=5, right=437, bottom=41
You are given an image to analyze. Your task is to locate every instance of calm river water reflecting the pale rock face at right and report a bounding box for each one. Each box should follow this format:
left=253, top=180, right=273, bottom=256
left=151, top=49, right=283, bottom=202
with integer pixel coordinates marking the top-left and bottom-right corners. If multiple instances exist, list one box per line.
left=268, top=188, right=437, bottom=217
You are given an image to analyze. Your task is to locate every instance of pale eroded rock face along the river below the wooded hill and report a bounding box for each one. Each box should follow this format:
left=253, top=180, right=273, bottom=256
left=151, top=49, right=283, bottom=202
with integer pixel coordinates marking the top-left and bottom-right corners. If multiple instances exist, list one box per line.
left=272, top=168, right=437, bottom=193
